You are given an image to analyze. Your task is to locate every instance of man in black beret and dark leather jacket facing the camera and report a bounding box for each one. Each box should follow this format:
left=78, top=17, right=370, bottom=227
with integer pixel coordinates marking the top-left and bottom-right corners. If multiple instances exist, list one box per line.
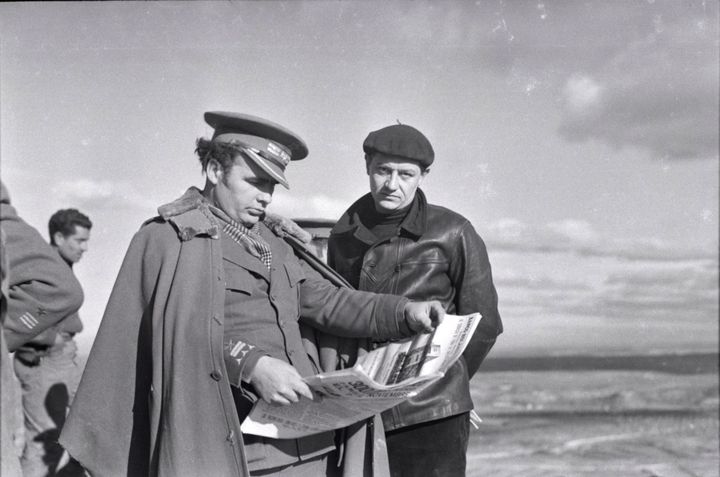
left=328, top=124, right=502, bottom=477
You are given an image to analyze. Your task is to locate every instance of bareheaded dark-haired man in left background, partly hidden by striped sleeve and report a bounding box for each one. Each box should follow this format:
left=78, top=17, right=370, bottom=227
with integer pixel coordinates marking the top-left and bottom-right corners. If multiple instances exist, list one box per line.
left=14, top=209, right=92, bottom=477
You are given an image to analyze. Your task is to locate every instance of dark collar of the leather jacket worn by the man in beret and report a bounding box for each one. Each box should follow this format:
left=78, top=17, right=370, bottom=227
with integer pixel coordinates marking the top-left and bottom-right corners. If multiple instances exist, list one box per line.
left=331, top=189, right=427, bottom=245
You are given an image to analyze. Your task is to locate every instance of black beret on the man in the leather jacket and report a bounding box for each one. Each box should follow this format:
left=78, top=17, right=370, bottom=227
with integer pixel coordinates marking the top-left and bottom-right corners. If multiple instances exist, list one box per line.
left=363, top=124, right=435, bottom=167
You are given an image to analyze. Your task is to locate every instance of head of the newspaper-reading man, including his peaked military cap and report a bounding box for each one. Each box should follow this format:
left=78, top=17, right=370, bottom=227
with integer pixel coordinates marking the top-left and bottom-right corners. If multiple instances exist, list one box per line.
left=195, top=112, right=308, bottom=227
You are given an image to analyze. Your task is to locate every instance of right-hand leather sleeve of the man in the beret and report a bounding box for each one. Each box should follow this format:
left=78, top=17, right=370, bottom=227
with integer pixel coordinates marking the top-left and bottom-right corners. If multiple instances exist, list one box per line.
left=451, top=222, right=502, bottom=378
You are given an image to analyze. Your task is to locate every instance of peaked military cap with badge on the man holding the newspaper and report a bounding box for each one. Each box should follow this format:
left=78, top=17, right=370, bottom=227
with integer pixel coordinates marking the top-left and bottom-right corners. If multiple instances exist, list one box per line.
left=205, top=111, right=308, bottom=188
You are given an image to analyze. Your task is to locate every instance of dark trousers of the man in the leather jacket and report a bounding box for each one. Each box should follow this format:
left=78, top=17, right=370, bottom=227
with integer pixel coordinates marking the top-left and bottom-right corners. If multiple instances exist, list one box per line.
left=385, top=413, right=470, bottom=477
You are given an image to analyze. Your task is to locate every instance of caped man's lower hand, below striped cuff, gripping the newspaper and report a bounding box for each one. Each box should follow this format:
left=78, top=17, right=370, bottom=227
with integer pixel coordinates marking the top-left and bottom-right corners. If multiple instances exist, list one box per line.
left=250, top=356, right=313, bottom=404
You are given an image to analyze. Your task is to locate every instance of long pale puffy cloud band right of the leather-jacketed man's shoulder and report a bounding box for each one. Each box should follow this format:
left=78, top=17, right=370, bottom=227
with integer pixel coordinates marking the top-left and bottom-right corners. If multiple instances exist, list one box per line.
left=484, top=218, right=718, bottom=262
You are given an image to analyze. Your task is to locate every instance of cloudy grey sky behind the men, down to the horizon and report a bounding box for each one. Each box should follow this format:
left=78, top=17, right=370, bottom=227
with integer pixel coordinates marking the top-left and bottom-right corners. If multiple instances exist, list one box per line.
left=0, top=0, right=720, bottom=356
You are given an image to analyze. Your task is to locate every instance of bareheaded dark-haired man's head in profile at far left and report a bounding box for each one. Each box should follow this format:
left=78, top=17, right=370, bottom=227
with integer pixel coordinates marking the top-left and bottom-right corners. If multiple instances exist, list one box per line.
left=48, top=209, right=92, bottom=264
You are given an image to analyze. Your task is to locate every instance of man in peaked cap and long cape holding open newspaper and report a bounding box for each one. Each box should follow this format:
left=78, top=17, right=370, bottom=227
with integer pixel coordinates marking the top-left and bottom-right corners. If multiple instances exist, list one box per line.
left=61, top=112, right=444, bottom=476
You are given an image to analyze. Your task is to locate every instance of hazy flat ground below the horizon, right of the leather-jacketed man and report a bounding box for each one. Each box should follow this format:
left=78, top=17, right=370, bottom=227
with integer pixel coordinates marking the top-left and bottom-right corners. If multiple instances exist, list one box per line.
left=468, top=355, right=720, bottom=477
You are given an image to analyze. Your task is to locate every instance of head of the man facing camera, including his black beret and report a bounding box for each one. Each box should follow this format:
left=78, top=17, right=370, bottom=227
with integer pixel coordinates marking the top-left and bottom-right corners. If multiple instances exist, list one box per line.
left=363, top=124, right=435, bottom=214
